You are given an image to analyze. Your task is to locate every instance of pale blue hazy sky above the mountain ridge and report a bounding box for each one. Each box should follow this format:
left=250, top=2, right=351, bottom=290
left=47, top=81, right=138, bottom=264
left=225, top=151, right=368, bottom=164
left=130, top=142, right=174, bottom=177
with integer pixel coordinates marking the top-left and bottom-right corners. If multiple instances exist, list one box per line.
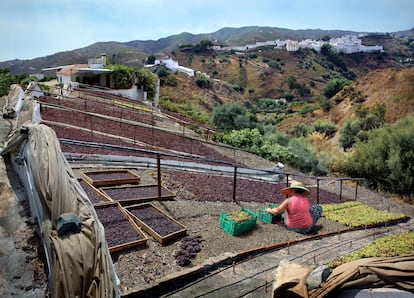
left=0, top=0, right=414, bottom=61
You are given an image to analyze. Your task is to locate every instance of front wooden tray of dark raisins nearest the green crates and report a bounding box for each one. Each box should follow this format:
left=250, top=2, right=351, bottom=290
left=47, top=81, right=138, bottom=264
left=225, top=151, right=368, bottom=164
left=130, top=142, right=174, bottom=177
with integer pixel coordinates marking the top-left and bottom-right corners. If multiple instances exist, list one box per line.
left=124, top=203, right=187, bottom=244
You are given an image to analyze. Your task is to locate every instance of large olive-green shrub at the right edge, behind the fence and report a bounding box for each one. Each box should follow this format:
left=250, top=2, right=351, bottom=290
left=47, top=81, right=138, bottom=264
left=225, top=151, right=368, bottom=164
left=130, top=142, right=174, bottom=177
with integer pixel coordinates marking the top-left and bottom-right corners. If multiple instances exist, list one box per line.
left=343, top=118, right=414, bottom=198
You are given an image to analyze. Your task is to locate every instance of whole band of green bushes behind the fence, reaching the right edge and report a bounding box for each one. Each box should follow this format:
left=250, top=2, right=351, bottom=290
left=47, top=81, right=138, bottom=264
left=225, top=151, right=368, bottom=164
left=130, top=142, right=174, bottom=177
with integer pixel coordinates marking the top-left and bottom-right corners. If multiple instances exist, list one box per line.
left=211, top=99, right=414, bottom=197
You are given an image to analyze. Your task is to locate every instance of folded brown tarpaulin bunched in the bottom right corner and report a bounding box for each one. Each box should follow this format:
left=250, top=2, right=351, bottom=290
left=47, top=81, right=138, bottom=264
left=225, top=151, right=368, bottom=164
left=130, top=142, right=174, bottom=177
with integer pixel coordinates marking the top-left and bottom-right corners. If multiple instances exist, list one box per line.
left=309, top=254, right=414, bottom=298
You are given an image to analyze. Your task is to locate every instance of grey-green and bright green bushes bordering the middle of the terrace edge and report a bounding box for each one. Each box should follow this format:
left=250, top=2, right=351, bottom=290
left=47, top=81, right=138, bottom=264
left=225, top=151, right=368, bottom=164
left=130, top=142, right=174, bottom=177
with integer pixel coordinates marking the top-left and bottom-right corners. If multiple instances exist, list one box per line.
left=211, top=99, right=331, bottom=175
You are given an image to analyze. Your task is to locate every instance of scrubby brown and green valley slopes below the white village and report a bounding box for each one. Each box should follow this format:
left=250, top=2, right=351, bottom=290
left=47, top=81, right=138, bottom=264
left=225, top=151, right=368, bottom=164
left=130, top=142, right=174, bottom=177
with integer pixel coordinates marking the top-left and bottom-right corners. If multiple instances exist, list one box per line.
left=160, top=37, right=414, bottom=197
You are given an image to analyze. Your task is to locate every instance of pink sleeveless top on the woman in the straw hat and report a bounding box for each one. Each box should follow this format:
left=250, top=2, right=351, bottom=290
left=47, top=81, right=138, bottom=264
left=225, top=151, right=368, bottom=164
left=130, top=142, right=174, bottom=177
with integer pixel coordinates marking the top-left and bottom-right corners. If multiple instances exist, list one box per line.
left=285, top=194, right=313, bottom=228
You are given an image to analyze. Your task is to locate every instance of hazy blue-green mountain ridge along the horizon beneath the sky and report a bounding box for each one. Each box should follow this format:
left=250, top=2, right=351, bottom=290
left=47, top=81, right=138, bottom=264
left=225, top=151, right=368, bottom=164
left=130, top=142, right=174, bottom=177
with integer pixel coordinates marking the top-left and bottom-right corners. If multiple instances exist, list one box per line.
left=0, top=26, right=414, bottom=74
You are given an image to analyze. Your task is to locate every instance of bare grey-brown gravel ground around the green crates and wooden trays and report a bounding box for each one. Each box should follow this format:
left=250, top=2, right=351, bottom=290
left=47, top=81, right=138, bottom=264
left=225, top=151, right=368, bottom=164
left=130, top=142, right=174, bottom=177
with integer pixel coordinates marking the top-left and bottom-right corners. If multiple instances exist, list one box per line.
left=98, top=147, right=413, bottom=291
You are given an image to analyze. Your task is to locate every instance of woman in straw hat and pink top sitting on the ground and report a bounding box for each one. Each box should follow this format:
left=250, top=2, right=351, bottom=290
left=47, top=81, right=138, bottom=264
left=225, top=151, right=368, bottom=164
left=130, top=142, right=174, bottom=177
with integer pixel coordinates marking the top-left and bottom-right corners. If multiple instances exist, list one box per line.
left=266, top=181, right=322, bottom=234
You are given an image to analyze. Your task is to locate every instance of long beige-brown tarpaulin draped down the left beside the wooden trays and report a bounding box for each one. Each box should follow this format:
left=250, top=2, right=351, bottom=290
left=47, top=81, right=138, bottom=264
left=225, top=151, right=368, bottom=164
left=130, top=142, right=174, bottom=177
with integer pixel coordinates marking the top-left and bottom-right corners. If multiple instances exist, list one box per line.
left=27, top=124, right=119, bottom=297
